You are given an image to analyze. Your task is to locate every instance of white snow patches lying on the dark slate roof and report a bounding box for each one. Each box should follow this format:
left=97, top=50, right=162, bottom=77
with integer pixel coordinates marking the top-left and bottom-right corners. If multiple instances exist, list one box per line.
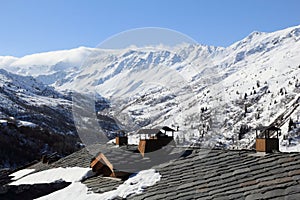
left=9, top=162, right=161, bottom=200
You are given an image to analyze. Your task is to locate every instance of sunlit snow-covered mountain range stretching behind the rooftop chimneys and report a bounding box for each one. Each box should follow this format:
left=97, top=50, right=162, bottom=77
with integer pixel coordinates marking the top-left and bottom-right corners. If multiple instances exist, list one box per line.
left=0, top=26, right=300, bottom=153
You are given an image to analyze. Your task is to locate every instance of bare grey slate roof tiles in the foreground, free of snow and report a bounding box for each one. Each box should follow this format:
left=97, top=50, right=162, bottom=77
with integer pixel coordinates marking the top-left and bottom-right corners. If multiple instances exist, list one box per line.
left=1, top=146, right=300, bottom=200
